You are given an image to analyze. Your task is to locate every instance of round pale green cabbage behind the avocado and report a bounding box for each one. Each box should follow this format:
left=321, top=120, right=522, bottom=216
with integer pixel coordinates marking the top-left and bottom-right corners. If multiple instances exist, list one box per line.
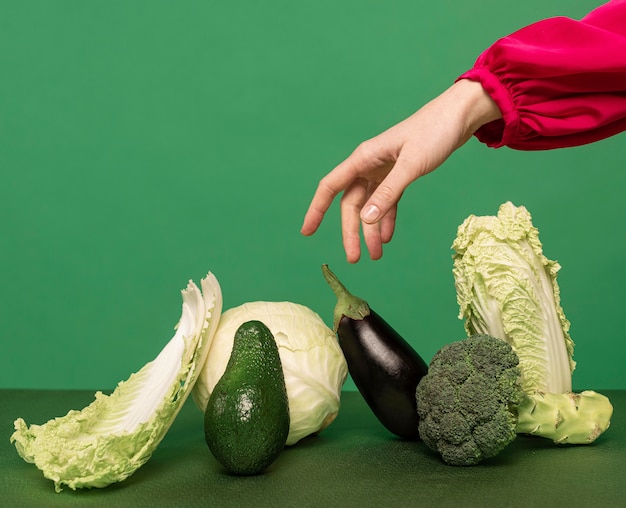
left=192, top=301, right=348, bottom=445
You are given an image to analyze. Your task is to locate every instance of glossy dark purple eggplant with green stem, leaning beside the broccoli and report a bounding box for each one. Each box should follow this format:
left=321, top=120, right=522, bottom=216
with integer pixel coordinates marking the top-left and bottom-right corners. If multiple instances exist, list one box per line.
left=322, top=265, right=428, bottom=439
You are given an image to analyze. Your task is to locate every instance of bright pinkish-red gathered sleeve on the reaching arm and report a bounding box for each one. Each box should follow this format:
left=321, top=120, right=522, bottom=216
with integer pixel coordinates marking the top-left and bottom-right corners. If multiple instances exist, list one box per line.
left=458, top=0, right=626, bottom=150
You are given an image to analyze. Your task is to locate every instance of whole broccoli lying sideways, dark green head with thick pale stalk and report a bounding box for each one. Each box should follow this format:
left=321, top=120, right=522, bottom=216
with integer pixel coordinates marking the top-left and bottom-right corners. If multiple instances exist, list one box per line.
left=416, top=334, right=612, bottom=466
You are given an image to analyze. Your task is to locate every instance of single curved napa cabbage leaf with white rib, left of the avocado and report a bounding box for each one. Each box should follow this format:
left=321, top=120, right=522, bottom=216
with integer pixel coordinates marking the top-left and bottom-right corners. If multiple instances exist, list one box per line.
left=11, top=273, right=222, bottom=492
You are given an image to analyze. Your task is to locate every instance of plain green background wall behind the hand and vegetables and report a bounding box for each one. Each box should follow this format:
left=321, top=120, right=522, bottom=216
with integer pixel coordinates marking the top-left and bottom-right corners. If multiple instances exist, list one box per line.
left=0, top=0, right=626, bottom=389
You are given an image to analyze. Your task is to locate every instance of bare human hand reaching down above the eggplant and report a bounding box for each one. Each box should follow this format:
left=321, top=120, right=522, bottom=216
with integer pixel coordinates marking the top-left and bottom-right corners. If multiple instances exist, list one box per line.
left=301, top=79, right=501, bottom=263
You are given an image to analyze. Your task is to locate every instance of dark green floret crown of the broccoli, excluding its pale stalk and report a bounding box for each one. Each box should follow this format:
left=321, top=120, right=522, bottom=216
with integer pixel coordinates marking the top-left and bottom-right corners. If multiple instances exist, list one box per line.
left=416, top=335, right=525, bottom=466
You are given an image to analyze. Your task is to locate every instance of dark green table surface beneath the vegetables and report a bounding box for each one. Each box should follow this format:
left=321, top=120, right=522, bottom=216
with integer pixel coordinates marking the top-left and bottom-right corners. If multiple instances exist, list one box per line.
left=0, top=390, right=626, bottom=508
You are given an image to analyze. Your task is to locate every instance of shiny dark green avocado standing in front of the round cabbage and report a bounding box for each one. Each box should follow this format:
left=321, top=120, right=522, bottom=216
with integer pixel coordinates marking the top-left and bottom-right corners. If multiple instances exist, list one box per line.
left=204, top=321, right=289, bottom=475
